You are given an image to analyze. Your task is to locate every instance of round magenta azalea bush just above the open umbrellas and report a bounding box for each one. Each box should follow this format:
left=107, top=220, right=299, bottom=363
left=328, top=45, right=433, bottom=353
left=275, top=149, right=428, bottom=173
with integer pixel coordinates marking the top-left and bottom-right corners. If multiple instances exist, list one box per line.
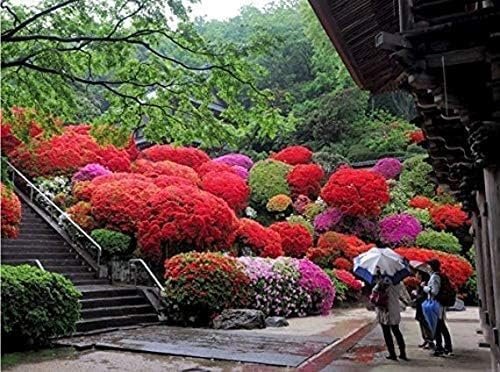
left=380, top=213, right=422, bottom=246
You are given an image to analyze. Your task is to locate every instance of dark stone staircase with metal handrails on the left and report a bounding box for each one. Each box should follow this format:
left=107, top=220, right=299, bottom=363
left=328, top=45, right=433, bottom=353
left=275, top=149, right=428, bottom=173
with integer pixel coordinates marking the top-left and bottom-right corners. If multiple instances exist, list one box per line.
left=1, top=201, right=158, bottom=332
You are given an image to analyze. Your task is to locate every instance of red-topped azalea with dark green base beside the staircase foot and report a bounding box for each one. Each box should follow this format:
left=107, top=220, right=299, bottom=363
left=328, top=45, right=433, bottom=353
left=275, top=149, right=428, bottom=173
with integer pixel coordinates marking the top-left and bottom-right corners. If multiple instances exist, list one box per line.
left=164, top=252, right=251, bottom=325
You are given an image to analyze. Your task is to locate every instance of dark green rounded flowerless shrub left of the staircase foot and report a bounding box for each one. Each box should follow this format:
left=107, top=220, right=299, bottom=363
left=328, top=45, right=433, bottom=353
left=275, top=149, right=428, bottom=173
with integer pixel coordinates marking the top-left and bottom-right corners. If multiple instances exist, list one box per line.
left=0, top=265, right=81, bottom=350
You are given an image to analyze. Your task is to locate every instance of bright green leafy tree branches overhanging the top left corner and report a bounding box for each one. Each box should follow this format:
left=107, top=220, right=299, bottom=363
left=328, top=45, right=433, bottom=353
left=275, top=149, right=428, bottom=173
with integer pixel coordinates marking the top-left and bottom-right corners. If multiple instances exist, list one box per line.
left=1, top=0, right=293, bottom=147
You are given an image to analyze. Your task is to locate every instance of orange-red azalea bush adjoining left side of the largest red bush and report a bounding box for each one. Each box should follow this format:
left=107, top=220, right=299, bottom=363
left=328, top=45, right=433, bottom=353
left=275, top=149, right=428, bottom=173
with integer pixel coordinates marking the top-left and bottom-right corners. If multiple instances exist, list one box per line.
left=90, top=176, right=159, bottom=233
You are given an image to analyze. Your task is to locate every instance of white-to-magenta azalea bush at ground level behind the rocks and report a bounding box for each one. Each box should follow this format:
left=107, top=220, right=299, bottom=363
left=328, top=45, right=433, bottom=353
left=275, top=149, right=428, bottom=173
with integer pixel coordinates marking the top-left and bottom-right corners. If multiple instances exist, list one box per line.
left=239, top=257, right=335, bottom=317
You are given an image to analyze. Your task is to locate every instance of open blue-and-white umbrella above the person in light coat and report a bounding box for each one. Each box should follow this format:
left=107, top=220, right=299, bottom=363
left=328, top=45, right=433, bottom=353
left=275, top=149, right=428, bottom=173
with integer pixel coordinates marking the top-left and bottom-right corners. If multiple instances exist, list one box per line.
left=354, top=247, right=411, bottom=284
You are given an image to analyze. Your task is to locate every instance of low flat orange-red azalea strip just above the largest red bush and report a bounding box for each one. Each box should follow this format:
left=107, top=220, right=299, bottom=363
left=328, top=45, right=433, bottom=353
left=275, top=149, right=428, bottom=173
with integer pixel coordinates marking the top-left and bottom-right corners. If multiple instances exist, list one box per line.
left=132, top=159, right=200, bottom=184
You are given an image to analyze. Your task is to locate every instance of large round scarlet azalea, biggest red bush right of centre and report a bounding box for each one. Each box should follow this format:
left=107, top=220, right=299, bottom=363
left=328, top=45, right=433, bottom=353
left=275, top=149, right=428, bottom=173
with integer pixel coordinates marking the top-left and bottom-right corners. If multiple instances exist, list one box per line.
left=321, top=167, right=389, bottom=217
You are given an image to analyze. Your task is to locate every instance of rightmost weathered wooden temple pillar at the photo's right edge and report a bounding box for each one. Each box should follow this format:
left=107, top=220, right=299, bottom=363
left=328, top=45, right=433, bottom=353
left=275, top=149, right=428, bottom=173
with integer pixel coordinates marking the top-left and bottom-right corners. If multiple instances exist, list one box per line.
left=484, top=168, right=500, bottom=362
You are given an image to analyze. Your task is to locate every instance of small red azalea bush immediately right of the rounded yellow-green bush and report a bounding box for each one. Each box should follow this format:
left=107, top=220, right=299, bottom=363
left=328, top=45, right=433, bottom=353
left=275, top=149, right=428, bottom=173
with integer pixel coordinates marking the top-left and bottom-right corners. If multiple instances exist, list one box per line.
left=286, top=164, right=325, bottom=199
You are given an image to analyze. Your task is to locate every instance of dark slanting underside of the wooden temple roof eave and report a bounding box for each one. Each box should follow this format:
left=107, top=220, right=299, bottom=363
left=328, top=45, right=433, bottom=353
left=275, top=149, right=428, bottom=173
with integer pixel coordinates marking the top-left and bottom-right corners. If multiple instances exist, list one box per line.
left=309, top=0, right=402, bottom=93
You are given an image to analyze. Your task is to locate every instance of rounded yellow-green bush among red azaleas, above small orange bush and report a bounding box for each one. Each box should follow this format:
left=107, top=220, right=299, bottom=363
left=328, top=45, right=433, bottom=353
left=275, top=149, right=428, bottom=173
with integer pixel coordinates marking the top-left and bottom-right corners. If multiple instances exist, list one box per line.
left=248, top=160, right=290, bottom=206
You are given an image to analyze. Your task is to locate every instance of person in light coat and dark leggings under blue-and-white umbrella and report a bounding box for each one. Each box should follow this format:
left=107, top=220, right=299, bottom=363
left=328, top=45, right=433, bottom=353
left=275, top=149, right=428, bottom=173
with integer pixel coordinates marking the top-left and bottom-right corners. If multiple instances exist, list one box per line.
left=370, top=278, right=411, bottom=361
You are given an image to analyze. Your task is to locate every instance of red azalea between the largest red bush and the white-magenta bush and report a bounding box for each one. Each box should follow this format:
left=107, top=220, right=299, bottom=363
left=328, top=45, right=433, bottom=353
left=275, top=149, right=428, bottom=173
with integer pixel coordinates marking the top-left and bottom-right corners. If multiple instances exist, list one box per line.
left=236, top=218, right=284, bottom=258
